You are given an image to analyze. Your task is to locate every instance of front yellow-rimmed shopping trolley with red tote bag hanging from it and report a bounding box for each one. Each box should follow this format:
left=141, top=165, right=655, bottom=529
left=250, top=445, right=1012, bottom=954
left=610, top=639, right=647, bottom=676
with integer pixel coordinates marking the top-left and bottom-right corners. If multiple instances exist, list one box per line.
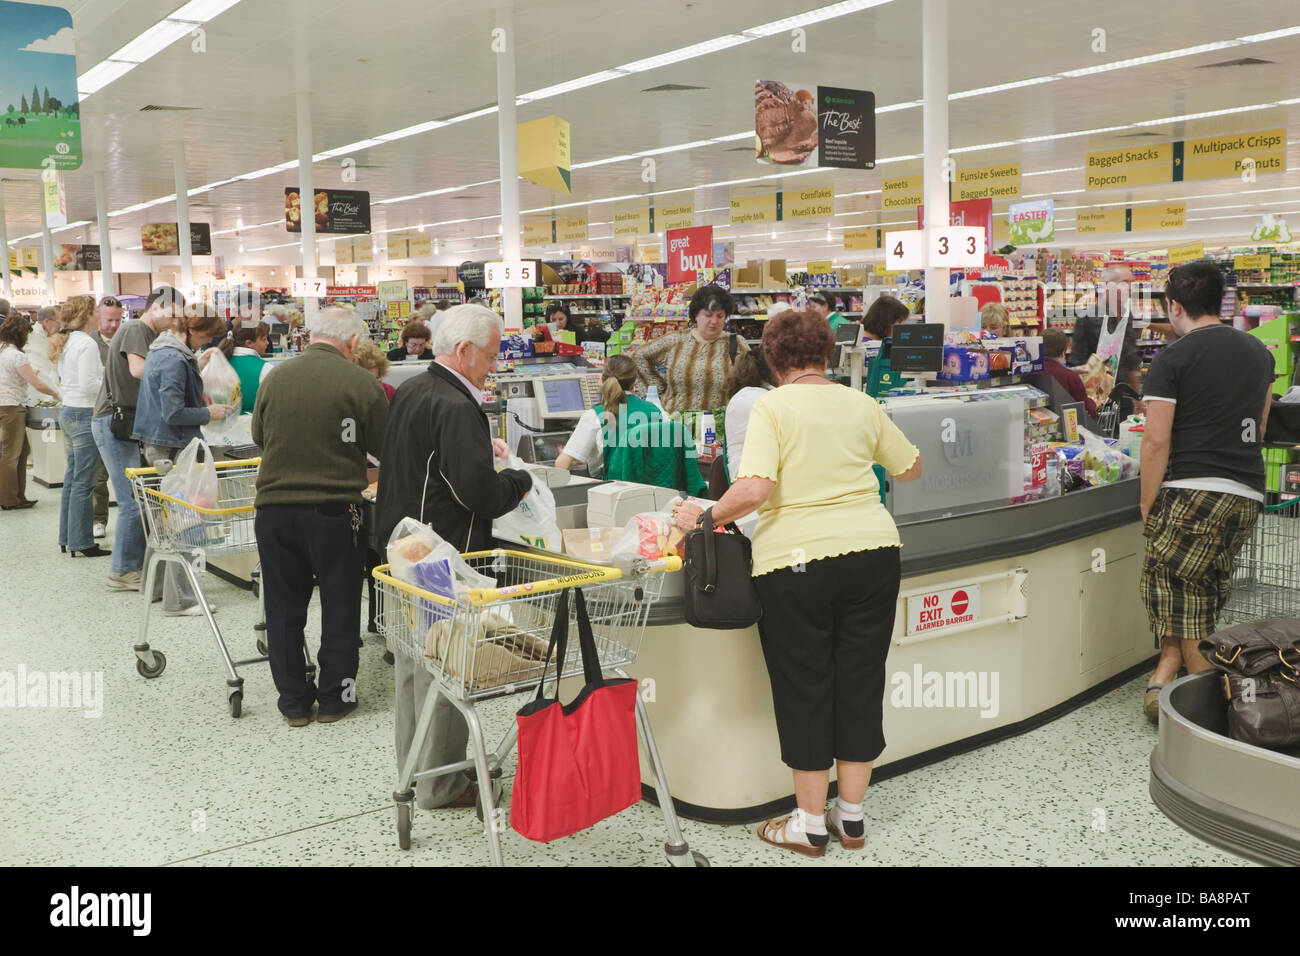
left=372, top=550, right=709, bottom=866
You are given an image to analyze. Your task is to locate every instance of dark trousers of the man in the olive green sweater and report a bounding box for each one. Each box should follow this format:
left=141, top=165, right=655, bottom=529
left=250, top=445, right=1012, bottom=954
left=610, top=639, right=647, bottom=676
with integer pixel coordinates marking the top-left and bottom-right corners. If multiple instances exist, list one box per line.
left=254, top=505, right=361, bottom=717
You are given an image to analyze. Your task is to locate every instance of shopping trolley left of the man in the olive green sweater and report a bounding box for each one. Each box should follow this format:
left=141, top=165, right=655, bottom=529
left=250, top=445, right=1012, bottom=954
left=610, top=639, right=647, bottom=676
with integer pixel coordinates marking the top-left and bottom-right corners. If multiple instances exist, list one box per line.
left=126, top=458, right=316, bottom=717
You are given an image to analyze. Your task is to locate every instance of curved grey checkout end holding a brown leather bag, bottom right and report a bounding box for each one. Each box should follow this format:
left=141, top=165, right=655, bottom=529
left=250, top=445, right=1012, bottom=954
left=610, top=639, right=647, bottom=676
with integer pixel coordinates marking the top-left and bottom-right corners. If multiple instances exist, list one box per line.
left=1151, top=671, right=1300, bottom=866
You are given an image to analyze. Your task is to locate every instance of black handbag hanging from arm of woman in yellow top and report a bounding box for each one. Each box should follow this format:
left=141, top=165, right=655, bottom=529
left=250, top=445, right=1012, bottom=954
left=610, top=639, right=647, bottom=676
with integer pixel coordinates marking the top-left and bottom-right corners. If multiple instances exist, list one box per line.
left=683, top=510, right=763, bottom=631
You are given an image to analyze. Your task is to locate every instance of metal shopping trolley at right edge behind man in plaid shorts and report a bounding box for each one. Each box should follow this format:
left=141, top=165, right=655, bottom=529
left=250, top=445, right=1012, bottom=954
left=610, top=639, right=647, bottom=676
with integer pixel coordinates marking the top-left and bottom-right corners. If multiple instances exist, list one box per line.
left=1219, top=499, right=1300, bottom=624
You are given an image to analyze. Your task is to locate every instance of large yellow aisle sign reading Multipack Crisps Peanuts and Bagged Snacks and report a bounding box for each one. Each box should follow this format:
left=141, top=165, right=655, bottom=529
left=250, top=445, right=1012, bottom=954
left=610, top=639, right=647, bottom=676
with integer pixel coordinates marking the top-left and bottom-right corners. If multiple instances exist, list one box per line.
left=1084, top=129, right=1287, bottom=190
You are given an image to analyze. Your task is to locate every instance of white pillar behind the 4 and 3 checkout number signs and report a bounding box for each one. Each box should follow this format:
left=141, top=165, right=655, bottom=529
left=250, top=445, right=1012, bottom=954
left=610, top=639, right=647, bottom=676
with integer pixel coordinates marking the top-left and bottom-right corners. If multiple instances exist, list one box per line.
left=920, top=0, right=950, bottom=328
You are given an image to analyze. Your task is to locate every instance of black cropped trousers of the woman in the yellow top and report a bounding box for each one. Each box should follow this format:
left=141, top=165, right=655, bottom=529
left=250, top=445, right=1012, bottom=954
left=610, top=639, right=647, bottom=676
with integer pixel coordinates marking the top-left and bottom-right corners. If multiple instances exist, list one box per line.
left=754, top=548, right=902, bottom=770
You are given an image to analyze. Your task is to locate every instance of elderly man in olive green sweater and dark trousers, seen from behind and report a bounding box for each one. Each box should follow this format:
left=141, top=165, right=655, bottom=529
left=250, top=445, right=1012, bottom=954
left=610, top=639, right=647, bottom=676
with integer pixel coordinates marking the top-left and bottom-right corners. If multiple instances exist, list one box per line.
left=252, top=308, right=389, bottom=727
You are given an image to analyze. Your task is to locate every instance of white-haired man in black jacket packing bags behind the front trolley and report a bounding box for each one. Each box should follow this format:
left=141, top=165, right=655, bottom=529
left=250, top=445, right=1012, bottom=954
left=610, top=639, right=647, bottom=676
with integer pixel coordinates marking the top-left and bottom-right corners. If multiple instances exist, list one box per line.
left=376, top=306, right=532, bottom=809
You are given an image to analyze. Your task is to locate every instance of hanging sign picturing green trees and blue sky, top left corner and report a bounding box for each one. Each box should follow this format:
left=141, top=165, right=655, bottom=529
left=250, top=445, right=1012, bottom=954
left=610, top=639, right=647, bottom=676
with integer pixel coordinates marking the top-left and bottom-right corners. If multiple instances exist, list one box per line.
left=0, top=3, right=82, bottom=169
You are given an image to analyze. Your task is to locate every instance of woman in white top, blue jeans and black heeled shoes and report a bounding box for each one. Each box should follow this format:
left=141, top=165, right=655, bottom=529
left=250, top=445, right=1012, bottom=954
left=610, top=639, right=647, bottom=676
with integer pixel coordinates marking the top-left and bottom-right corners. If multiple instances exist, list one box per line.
left=49, top=295, right=112, bottom=558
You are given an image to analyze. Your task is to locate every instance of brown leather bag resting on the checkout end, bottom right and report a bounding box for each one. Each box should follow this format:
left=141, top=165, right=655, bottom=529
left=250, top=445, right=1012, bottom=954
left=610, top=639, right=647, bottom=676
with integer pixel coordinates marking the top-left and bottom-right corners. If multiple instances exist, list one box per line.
left=1200, top=618, right=1300, bottom=750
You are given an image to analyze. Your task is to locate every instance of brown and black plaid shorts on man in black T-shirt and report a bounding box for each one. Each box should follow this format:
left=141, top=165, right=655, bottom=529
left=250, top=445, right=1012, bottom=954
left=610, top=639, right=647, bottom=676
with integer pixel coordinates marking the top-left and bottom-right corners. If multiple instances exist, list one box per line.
left=1140, top=488, right=1261, bottom=649
